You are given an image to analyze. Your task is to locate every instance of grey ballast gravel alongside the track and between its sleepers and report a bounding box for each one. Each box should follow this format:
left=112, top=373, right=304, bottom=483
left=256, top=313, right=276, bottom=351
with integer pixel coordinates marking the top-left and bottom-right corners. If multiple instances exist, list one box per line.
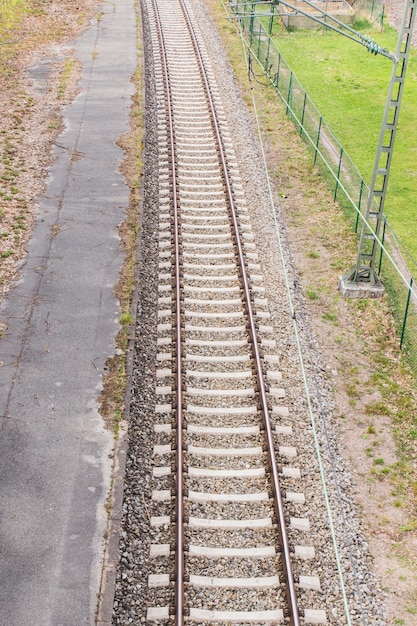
left=113, top=0, right=386, bottom=626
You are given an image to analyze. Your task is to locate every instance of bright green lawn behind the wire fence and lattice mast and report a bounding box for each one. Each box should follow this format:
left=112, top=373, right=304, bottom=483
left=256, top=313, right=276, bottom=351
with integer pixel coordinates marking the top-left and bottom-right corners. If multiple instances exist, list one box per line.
left=273, top=20, right=417, bottom=258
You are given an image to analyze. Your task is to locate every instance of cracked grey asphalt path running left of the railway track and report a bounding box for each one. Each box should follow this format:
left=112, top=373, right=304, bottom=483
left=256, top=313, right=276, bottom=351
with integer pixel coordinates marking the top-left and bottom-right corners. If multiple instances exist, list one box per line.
left=0, top=0, right=136, bottom=626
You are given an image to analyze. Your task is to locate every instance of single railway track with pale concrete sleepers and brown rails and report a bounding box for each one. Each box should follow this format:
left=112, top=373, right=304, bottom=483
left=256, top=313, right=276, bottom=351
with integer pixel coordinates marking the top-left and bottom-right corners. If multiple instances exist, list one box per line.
left=141, top=0, right=336, bottom=626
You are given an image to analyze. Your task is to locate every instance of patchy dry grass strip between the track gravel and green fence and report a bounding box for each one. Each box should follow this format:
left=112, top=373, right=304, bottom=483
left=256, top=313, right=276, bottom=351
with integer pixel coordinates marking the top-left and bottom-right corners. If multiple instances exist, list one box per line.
left=207, top=0, right=417, bottom=626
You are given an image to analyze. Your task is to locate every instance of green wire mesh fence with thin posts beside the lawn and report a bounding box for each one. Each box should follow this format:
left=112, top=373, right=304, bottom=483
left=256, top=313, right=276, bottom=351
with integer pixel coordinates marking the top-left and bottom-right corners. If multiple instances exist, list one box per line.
left=229, top=0, right=417, bottom=375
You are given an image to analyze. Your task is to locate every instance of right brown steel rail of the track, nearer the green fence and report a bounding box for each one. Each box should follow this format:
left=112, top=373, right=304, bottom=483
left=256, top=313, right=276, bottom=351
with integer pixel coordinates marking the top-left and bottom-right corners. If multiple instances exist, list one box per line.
left=178, top=0, right=300, bottom=626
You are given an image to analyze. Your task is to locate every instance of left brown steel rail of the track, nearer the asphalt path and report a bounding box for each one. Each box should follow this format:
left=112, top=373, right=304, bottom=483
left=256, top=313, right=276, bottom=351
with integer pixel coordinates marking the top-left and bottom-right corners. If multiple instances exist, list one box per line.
left=148, top=0, right=185, bottom=626
